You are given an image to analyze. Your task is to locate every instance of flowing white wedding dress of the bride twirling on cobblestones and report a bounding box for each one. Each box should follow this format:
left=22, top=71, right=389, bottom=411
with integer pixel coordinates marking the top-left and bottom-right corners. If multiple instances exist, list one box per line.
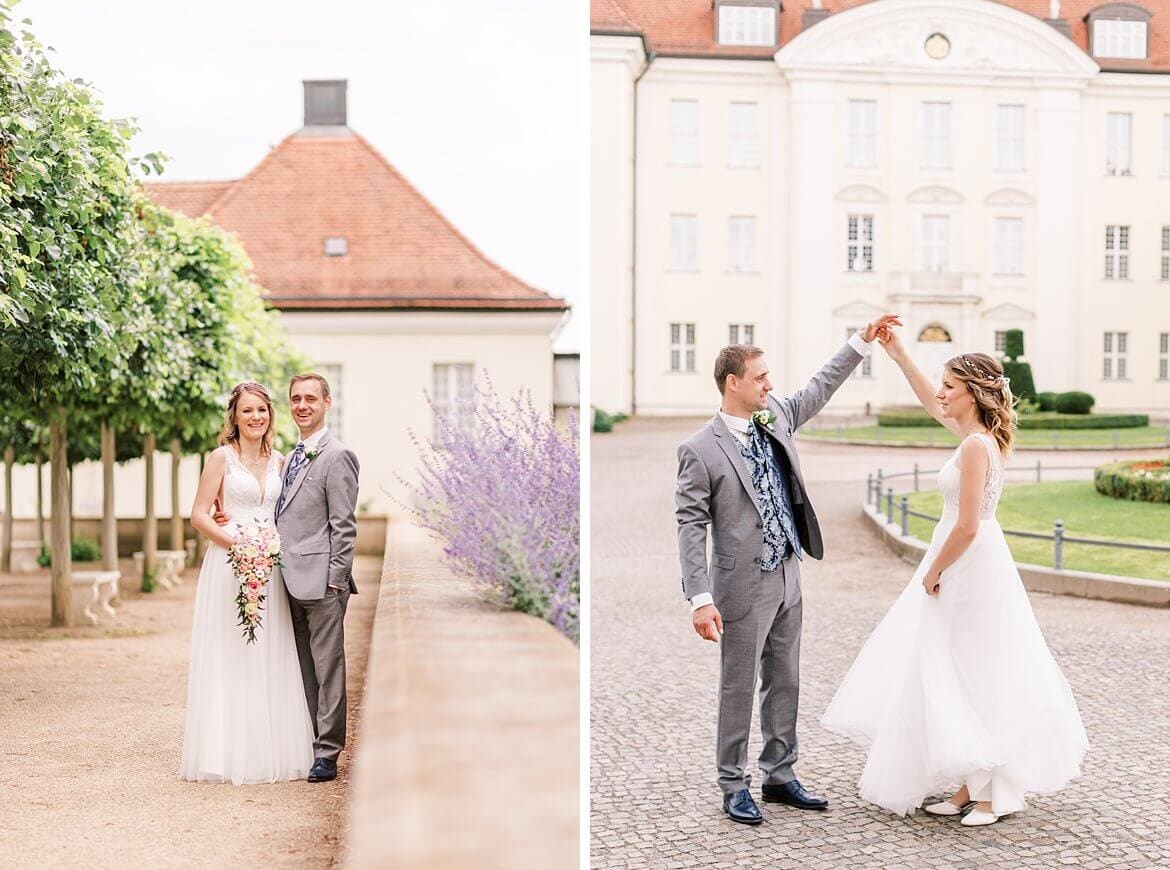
left=821, top=435, right=1088, bottom=815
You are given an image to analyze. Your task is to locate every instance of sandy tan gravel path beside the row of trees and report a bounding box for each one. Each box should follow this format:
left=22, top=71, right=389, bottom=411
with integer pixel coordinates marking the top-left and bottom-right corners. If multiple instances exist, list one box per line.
left=0, top=558, right=380, bottom=868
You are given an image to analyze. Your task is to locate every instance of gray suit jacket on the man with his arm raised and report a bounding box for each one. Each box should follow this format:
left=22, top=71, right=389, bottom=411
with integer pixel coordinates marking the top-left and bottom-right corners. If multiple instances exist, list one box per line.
left=675, top=344, right=862, bottom=621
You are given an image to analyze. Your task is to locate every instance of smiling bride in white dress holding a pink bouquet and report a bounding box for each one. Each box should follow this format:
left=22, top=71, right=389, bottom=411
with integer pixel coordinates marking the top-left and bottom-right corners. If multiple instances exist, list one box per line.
left=179, top=381, right=312, bottom=785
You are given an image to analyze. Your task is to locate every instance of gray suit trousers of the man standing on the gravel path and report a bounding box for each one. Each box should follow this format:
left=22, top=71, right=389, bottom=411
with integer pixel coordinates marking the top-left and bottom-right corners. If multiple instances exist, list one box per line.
left=289, top=588, right=350, bottom=761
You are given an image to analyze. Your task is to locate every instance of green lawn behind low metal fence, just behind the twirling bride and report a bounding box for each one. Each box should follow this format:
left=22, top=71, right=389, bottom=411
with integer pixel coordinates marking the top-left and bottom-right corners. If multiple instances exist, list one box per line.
left=894, top=481, right=1170, bottom=580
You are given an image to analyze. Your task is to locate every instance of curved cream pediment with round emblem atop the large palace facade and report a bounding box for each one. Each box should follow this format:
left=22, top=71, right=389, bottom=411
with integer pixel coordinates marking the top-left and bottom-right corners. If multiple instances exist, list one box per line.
left=775, top=0, right=1100, bottom=78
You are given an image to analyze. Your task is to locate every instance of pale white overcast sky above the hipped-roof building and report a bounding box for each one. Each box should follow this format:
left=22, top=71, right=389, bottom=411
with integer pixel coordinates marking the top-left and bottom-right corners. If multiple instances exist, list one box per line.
left=14, top=0, right=589, bottom=346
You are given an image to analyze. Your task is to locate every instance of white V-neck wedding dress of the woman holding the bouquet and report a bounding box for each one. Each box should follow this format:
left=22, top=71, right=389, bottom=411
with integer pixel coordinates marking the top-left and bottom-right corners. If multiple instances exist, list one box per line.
left=179, top=446, right=314, bottom=786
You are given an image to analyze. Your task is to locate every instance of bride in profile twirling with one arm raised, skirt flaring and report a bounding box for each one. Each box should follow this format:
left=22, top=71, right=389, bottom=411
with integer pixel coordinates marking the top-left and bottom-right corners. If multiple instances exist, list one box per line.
left=821, top=331, right=1088, bottom=826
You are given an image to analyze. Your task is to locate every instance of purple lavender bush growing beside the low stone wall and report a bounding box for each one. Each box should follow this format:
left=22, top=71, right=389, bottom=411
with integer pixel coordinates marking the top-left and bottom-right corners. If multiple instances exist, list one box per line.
left=404, top=381, right=580, bottom=642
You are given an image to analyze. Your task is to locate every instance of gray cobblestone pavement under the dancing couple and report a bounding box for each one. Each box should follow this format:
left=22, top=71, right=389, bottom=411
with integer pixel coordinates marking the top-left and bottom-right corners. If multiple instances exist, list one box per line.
left=591, top=420, right=1170, bottom=869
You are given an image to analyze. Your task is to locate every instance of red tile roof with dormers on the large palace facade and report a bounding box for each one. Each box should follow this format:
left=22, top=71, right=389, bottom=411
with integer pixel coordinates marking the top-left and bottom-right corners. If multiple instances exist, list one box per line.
left=590, top=0, right=1170, bottom=73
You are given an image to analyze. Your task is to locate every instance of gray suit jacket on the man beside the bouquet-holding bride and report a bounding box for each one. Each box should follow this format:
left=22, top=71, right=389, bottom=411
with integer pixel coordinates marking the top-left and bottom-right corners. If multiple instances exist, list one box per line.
left=276, top=431, right=358, bottom=601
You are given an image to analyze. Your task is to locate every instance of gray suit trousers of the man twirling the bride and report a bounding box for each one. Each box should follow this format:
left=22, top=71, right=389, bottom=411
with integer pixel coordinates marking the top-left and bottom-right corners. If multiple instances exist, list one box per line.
left=715, top=555, right=804, bottom=794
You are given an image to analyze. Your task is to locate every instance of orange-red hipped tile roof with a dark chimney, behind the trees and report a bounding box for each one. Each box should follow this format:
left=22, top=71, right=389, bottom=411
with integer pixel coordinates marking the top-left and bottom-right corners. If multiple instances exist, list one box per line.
left=146, top=127, right=566, bottom=310
